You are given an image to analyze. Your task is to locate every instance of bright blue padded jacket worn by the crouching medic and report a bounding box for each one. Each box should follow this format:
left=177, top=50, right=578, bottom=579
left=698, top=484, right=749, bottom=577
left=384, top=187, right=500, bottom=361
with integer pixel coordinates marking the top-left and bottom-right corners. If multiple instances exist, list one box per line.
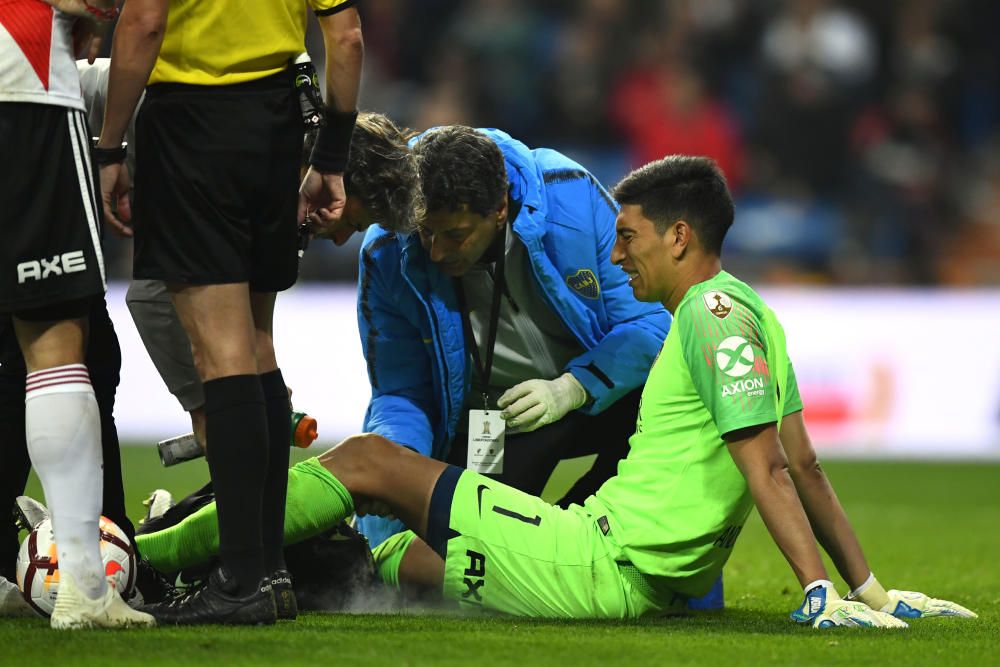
left=358, top=129, right=670, bottom=541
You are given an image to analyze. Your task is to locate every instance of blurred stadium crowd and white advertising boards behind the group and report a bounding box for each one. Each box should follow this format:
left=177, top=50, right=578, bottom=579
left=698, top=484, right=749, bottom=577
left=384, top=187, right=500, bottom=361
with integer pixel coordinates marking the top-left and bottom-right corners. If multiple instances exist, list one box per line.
left=97, top=0, right=1000, bottom=457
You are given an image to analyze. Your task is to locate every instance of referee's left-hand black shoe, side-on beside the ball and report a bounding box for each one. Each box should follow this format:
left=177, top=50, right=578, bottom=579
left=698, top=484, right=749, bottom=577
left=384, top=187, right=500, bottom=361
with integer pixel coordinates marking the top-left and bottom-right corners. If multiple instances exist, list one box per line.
left=142, top=567, right=276, bottom=625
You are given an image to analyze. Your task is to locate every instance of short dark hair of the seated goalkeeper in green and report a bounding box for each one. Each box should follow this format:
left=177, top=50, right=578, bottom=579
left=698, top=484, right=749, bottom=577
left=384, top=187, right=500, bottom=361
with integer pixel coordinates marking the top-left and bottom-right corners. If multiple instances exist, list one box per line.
left=614, top=155, right=733, bottom=255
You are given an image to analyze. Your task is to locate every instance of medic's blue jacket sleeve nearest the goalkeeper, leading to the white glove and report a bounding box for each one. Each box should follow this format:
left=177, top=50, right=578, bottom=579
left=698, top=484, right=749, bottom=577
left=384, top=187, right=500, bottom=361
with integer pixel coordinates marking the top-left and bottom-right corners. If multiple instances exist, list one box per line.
left=566, top=177, right=670, bottom=414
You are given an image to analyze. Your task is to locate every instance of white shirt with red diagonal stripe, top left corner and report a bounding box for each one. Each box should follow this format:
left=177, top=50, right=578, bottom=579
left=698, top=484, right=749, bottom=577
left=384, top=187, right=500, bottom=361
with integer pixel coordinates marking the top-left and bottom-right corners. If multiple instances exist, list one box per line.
left=0, top=0, right=84, bottom=111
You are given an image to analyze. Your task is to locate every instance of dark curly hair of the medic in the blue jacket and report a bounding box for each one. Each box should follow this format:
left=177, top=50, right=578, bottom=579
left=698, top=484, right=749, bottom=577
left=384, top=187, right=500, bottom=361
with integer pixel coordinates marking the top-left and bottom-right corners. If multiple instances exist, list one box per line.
left=413, top=125, right=507, bottom=216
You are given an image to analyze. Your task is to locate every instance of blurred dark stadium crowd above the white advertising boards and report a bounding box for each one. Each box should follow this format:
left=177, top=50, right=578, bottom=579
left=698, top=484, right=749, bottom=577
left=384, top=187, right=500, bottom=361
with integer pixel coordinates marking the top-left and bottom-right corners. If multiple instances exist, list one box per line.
left=207, top=0, right=988, bottom=285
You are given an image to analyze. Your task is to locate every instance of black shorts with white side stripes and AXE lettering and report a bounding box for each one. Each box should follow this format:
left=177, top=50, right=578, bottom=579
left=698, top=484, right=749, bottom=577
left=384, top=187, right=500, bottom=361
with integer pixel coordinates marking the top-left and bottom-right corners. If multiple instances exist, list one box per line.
left=0, top=102, right=105, bottom=319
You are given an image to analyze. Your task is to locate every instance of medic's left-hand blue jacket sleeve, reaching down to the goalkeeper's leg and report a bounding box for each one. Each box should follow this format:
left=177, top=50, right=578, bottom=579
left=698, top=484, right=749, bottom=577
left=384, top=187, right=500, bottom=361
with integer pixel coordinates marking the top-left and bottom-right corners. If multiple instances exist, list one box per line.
left=358, top=237, right=437, bottom=456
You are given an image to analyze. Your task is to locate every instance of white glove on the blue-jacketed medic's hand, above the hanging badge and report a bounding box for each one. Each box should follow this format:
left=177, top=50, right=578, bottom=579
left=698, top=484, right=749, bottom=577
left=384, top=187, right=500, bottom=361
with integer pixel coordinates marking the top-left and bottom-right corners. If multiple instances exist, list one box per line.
left=497, top=373, right=587, bottom=433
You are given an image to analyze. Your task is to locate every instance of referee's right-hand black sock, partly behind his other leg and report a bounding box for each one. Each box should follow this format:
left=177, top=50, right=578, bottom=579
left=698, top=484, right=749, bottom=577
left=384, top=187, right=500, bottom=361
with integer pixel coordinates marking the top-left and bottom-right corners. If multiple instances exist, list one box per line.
left=260, top=369, right=292, bottom=574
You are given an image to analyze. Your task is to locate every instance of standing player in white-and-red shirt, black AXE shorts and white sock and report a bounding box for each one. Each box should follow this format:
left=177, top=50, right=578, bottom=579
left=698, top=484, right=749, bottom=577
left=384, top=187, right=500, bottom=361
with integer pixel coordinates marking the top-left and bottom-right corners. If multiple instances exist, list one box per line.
left=0, top=0, right=153, bottom=628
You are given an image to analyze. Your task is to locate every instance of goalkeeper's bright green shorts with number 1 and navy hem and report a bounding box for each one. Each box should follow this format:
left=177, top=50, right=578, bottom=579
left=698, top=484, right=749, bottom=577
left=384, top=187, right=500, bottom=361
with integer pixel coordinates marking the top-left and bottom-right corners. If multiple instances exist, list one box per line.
left=428, top=468, right=686, bottom=618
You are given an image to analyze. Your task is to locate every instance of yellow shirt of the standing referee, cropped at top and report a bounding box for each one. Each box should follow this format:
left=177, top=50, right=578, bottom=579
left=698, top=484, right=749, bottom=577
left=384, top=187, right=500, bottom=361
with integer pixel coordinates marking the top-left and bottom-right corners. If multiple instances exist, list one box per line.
left=149, top=0, right=355, bottom=86
